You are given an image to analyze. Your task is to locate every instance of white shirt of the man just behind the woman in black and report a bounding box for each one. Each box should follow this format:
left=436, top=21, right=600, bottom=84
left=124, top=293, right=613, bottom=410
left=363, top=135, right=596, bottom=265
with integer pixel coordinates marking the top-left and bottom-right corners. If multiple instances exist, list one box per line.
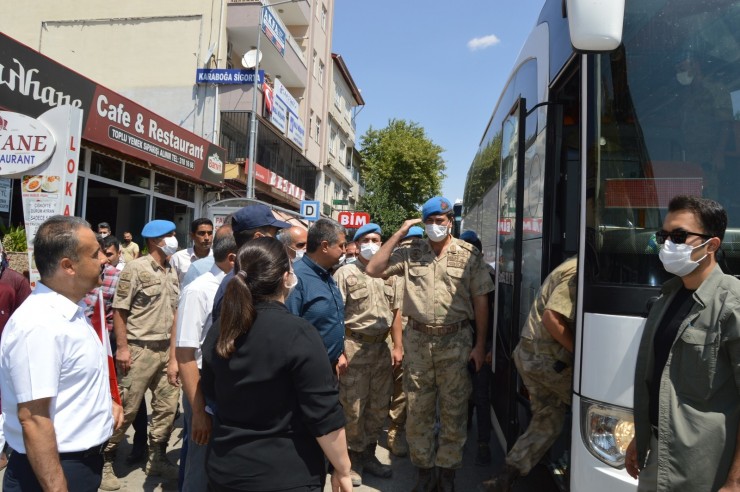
left=176, top=264, right=226, bottom=368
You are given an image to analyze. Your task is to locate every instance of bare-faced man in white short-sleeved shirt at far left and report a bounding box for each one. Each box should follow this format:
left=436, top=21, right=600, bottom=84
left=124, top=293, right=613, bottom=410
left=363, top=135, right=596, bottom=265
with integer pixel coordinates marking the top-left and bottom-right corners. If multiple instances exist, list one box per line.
left=0, top=216, right=123, bottom=492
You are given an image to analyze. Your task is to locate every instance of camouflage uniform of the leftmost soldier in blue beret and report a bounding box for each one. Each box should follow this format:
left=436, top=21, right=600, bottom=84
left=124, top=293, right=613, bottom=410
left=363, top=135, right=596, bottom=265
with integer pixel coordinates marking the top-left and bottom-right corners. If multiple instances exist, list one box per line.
left=106, top=255, right=180, bottom=452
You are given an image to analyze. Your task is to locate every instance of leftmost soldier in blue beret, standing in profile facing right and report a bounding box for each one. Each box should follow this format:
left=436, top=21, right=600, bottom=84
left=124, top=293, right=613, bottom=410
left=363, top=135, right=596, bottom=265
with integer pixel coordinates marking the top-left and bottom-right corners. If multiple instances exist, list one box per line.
left=100, top=220, right=180, bottom=490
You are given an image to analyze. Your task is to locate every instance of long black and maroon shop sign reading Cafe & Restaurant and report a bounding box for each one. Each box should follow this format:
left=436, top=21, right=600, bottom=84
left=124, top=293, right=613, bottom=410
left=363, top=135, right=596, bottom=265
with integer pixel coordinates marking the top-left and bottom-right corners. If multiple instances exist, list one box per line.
left=0, top=33, right=226, bottom=185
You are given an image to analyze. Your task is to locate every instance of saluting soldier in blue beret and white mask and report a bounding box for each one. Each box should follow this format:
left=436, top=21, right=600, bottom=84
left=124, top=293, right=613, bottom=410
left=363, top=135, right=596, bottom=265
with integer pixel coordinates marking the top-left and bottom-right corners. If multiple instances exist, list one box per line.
left=366, top=197, right=493, bottom=492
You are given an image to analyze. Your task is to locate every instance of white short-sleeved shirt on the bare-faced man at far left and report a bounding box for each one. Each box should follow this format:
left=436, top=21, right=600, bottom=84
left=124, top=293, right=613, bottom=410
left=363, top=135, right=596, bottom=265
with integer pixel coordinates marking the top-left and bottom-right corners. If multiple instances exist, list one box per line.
left=0, top=283, right=113, bottom=453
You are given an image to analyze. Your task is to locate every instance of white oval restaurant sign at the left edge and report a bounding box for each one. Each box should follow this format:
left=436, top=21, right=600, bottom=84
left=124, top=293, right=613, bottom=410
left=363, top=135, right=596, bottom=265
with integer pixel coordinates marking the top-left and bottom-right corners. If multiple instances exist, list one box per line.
left=0, top=111, right=56, bottom=176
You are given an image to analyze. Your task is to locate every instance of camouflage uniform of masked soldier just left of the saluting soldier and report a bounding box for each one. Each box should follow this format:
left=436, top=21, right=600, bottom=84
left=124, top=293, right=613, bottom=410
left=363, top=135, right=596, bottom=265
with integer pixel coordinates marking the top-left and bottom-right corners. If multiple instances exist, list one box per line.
left=334, top=261, right=395, bottom=453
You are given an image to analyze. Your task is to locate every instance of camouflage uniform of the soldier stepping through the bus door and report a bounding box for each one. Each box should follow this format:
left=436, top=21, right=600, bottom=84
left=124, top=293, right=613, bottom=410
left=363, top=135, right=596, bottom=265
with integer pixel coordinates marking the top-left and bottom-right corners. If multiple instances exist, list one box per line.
left=506, top=257, right=578, bottom=475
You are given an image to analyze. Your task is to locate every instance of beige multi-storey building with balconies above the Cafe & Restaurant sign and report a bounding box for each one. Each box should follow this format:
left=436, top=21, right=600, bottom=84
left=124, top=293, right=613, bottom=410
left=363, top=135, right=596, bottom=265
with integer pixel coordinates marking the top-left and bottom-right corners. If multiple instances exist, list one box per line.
left=0, top=0, right=359, bottom=222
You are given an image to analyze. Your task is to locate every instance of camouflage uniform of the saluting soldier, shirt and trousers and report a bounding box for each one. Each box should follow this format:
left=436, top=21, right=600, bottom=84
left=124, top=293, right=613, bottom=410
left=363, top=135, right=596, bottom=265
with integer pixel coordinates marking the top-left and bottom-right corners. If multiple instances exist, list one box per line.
left=384, top=238, right=493, bottom=469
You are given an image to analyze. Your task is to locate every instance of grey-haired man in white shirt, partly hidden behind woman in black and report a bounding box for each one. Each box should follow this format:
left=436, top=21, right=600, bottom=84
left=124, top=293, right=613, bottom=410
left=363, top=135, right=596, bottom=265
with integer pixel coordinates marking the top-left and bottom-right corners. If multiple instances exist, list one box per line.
left=175, top=225, right=237, bottom=492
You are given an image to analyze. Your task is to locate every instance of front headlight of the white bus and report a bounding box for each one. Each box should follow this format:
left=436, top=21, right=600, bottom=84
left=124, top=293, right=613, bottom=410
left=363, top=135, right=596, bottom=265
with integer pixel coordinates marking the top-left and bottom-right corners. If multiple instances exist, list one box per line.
left=581, top=398, right=635, bottom=468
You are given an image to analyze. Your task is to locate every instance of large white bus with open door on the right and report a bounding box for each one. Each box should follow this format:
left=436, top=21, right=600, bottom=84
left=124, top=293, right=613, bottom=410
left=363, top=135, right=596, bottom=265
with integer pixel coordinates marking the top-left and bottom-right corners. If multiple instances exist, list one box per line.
left=461, top=0, right=740, bottom=492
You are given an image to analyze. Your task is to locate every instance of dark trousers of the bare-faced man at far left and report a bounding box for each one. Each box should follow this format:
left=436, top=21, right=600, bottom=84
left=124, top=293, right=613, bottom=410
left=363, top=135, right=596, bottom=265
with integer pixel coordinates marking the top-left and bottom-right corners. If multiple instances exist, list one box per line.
left=3, top=452, right=103, bottom=492
